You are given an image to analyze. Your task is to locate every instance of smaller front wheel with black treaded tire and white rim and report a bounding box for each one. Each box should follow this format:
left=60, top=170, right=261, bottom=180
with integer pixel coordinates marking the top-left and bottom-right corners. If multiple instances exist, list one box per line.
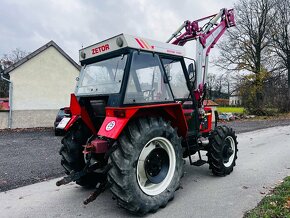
left=207, top=126, right=238, bottom=176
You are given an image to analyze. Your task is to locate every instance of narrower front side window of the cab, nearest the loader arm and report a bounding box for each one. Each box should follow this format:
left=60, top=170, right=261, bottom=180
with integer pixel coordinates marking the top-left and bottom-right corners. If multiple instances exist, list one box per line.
left=162, top=58, right=189, bottom=99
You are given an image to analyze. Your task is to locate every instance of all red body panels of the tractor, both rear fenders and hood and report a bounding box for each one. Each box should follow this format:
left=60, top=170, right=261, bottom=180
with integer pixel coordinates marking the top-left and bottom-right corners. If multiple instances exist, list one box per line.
left=65, top=94, right=212, bottom=140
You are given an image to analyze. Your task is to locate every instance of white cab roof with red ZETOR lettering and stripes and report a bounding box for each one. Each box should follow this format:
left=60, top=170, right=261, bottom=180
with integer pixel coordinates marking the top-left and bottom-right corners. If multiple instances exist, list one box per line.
left=79, top=34, right=185, bottom=62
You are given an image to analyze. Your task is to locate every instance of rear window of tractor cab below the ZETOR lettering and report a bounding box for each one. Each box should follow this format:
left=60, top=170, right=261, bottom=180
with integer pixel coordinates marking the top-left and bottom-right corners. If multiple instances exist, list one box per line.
left=75, top=55, right=127, bottom=96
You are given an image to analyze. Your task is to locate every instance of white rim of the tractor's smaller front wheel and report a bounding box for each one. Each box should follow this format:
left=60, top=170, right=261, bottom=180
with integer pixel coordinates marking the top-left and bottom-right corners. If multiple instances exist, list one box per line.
left=223, top=136, right=236, bottom=167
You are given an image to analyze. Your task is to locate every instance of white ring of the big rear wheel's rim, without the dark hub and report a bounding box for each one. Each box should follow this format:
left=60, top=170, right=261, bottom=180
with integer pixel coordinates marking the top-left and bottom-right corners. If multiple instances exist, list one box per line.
left=136, top=137, right=176, bottom=196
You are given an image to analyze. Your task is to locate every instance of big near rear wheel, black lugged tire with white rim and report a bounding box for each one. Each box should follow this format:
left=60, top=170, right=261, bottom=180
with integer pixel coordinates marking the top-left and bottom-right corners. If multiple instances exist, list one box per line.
left=108, top=118, right=183, bottom=215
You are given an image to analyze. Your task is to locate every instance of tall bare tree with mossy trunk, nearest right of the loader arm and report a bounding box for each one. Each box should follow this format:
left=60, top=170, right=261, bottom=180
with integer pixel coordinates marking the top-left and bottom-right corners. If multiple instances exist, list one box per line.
left=215, top=0, right=276, bottom=111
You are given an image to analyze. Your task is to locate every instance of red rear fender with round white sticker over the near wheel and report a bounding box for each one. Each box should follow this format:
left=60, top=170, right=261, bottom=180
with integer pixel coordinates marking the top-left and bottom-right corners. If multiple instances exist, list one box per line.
left=98, top=103, right=188, bottom=139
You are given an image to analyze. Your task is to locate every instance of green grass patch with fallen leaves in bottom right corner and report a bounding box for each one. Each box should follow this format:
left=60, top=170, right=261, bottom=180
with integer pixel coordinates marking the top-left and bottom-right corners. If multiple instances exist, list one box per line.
left=244, top=176, right=290, bottom=218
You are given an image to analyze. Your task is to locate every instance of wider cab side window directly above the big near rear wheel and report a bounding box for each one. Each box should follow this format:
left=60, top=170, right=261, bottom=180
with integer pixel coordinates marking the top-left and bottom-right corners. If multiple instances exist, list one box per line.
left=124, top=52, right=173, bottom=104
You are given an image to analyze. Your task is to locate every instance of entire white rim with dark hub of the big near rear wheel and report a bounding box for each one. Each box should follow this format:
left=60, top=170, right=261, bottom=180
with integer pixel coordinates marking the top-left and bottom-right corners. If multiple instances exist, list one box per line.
left=136, top=137, right=176, bottom=195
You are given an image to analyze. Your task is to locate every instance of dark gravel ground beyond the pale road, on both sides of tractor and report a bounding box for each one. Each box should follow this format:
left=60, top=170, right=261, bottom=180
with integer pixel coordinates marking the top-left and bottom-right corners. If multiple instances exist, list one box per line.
left=0, top=119, right=290, bottom=192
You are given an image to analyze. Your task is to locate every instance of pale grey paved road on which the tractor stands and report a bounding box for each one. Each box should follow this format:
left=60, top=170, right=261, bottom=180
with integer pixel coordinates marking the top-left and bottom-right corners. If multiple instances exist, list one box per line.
left=0, top=125, right=290, bottom=218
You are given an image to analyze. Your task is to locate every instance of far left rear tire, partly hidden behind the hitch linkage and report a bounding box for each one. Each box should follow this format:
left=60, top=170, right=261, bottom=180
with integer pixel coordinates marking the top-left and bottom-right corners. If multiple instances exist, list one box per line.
left=59, top=122, right=99, bottom=188
